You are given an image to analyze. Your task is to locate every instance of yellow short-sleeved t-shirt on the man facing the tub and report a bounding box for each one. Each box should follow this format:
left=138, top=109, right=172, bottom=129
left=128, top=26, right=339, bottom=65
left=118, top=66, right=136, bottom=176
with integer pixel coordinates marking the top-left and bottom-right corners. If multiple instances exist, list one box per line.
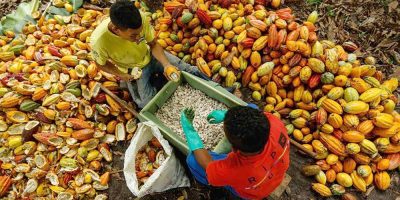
left=90, top=13, right=155, bottom=73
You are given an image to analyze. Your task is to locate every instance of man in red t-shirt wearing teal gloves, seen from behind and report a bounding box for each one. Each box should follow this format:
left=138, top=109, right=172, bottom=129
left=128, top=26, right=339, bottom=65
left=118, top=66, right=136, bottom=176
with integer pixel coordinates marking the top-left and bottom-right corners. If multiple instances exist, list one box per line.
left=181, top=106, right=289, bottom=199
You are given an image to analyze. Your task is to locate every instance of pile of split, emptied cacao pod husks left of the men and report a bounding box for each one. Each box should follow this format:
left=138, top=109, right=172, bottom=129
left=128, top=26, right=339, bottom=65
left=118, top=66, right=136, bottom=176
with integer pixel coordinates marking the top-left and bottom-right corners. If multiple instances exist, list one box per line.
left=0, top=9, right=136, bottom=200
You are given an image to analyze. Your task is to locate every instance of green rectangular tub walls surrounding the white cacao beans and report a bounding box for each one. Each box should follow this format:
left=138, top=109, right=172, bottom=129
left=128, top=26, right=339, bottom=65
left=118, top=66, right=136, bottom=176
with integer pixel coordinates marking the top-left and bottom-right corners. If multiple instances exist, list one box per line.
left=139, top=72, right=247, bottom=155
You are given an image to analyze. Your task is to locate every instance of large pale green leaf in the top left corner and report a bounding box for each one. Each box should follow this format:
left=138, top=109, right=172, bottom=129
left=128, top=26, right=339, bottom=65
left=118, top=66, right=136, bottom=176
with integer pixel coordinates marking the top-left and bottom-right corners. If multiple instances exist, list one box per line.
left=0, top=0, right=40, bottom=34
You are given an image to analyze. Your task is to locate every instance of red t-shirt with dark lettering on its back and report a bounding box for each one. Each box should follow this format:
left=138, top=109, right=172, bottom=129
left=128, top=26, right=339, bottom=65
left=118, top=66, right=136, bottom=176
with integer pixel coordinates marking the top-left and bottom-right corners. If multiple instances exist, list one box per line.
left=206, top=113, right=290, bottom=199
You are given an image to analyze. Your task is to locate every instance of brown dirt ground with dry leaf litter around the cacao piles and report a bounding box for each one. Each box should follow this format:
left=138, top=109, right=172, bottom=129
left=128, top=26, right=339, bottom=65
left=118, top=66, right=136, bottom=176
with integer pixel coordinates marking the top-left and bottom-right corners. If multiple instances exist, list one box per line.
left=0, top=0, right=400, bottom=200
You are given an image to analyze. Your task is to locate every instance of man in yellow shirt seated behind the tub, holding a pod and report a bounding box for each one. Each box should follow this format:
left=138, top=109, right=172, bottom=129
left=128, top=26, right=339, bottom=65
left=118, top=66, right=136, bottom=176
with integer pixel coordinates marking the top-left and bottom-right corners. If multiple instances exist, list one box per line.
left=90, top=0, right=206, bottom=108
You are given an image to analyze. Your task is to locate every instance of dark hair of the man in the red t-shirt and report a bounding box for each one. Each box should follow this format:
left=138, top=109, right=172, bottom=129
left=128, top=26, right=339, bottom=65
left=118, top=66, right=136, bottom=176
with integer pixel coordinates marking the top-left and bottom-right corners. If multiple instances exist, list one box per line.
left=224, top=106, right=269, bottom=153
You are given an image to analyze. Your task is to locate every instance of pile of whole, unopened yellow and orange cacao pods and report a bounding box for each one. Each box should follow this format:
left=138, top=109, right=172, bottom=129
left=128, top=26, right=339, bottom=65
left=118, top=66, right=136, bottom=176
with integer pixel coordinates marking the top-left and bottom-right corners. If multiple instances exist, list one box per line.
left=152, top=0, right=400, bottom=196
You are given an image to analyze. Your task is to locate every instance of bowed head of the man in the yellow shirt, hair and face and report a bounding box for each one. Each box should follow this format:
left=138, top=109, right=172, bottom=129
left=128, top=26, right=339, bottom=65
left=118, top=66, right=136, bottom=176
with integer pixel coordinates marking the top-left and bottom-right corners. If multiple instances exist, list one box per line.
left=110, top=0, right=142, bottom=42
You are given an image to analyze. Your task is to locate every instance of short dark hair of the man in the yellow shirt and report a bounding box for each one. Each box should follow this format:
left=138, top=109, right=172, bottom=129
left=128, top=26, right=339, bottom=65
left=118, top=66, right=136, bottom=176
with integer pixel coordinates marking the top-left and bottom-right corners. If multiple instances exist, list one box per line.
left=110, top=0, right=142, bottom=29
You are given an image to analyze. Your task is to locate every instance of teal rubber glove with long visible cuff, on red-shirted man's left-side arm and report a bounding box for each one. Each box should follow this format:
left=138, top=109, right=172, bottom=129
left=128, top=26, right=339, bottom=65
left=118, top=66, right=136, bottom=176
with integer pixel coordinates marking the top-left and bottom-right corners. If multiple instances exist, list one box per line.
left=181, top=108, right=204, bottom=151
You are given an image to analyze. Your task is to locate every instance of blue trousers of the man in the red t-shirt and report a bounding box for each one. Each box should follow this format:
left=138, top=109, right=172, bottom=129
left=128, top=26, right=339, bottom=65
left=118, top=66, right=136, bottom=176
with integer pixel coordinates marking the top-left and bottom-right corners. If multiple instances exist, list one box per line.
left=186, top=151, right=239, bottom=196
